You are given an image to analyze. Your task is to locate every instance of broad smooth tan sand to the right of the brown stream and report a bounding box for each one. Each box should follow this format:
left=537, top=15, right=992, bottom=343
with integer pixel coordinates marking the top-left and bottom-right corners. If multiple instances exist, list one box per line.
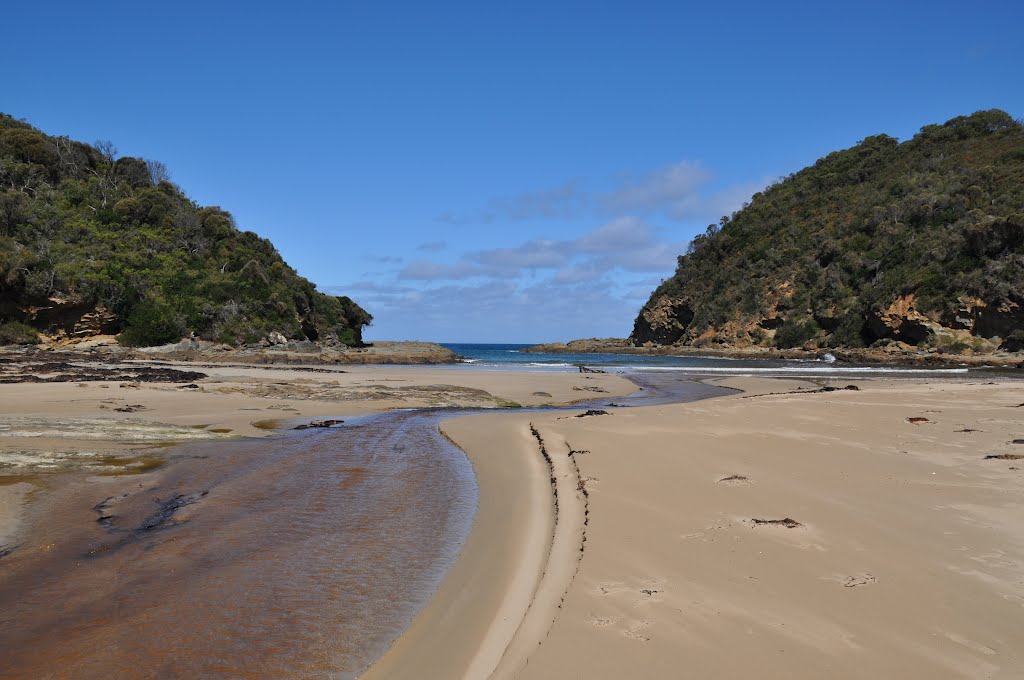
left=367, top=380, right=1024, bottom=678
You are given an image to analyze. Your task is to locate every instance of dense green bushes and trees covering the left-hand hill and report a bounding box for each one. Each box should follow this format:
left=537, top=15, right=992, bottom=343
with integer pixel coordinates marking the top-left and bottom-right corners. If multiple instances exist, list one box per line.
left=0, top=114, right=372, bottom=346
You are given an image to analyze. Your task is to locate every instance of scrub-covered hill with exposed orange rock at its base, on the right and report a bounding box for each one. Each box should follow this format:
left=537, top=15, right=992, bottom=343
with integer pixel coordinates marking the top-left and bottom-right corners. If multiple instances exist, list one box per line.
left=630, top=111, right=1024, bottom=353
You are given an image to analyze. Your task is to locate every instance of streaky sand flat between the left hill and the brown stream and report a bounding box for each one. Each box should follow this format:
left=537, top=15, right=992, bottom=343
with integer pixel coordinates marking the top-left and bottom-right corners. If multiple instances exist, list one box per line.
left=0, top=363, right=635, bottom=551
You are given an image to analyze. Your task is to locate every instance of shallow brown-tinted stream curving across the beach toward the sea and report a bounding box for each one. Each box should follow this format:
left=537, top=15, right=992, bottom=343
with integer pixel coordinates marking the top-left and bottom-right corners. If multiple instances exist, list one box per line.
left=0, top=374, right=727, bottom=679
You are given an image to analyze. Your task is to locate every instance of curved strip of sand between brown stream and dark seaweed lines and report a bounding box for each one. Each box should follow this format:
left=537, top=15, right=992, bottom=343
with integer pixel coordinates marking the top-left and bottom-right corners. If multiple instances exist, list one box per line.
left=359, top=378, right=770, bottom=680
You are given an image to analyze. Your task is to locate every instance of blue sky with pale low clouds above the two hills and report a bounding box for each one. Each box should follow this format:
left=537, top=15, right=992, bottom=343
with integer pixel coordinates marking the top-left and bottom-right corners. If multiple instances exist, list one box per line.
left=0, top=1, right=1024, bottom=342
